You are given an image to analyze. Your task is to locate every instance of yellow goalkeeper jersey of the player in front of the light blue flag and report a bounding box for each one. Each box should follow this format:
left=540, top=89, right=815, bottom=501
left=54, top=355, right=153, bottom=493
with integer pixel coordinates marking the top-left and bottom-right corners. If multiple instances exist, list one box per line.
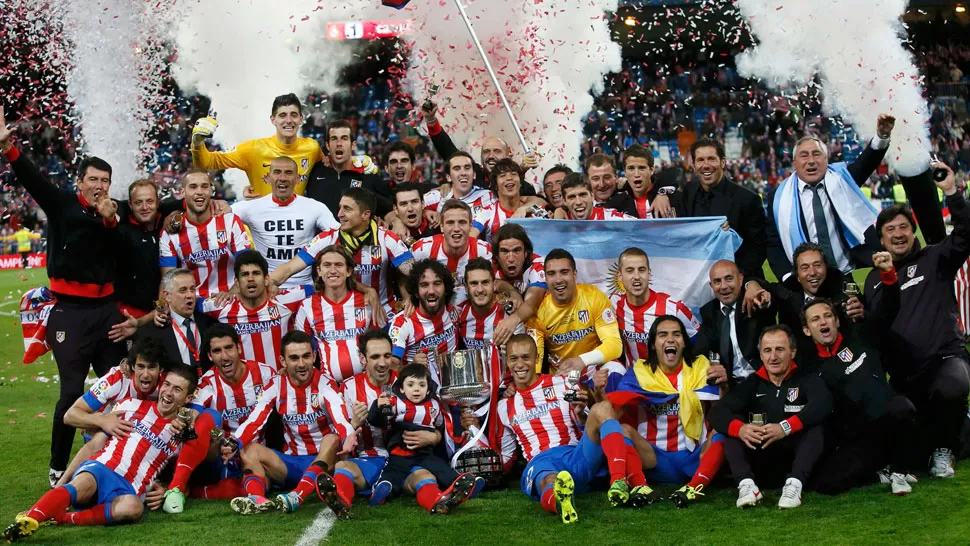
left=526, top=284, right=623, bottom=371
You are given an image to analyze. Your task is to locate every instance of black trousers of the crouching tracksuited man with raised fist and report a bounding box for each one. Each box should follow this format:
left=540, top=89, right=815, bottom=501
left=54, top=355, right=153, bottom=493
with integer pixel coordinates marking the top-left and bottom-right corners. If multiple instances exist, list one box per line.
left=814, top=395, right=921, bottom=495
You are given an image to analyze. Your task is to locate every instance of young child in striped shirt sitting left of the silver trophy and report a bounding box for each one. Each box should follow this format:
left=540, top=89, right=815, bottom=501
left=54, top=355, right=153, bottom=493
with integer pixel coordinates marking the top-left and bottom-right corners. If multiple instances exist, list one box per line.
left=367, top=364, right=475, bottom=514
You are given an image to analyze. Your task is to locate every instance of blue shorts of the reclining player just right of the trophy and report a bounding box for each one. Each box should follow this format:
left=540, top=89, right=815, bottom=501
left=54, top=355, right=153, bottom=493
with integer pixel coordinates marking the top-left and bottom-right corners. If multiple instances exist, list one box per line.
left=521, top=434, right=606, bottom=501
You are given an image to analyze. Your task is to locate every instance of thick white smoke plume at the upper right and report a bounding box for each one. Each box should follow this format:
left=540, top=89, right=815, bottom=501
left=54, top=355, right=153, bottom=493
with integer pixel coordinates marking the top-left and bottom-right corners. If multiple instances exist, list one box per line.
left=737, top=0, right=930, bottom=176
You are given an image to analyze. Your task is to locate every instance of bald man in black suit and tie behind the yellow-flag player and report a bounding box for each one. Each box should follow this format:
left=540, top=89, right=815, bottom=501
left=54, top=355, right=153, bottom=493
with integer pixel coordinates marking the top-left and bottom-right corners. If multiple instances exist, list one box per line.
left=696, top=260, right=776, bottom=385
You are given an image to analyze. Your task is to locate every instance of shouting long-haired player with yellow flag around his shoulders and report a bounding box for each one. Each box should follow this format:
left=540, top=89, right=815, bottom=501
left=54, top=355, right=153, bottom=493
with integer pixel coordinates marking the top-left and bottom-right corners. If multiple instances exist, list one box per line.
left=607, top=315, right=724, bottom=508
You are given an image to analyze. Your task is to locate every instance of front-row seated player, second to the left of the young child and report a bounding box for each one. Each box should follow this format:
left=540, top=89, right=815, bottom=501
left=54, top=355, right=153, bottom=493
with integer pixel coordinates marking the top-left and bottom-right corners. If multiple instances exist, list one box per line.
left=222, top=330, right=357, bottom=515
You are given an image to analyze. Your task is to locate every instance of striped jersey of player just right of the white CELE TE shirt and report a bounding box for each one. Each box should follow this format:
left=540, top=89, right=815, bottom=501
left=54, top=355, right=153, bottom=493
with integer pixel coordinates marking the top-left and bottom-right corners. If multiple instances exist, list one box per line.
left=297, top=228, right=411, bottom=318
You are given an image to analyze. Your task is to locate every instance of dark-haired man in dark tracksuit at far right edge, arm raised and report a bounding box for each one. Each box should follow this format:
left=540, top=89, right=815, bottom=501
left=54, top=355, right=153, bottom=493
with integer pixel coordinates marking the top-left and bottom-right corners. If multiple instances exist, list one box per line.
left=865, top=163, right=970, bottom=478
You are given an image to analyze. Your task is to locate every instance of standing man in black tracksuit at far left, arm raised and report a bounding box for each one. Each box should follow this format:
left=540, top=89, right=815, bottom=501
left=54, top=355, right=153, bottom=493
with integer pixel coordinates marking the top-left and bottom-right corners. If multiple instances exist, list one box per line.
left=0, top=133, right=126, bottom=487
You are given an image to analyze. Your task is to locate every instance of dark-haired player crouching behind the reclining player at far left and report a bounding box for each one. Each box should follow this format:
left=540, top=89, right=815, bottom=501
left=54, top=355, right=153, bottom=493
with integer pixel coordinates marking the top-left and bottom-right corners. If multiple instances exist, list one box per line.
left=57, top=339, right=168, bottom=485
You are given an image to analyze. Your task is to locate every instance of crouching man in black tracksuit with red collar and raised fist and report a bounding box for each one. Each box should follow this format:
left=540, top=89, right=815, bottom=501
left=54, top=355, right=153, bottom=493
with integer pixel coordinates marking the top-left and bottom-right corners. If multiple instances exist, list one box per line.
left=802, top=252, right=918, bottom=495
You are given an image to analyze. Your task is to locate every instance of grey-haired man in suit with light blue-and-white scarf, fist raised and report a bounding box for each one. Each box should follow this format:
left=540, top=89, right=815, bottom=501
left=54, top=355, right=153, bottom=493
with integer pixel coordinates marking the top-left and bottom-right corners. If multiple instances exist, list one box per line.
left=767, top=114, right=896, bottom=278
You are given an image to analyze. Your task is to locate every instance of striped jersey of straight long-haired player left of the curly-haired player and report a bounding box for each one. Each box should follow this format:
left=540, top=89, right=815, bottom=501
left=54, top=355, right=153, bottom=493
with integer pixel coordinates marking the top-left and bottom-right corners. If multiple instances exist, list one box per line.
left=293, top=290, right=373, bottom=383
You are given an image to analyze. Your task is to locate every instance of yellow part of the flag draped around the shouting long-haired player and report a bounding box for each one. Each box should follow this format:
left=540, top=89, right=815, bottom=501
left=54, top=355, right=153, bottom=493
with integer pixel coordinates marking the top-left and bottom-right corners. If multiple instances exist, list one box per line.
left=633, top=356, right=711, bottom=443
